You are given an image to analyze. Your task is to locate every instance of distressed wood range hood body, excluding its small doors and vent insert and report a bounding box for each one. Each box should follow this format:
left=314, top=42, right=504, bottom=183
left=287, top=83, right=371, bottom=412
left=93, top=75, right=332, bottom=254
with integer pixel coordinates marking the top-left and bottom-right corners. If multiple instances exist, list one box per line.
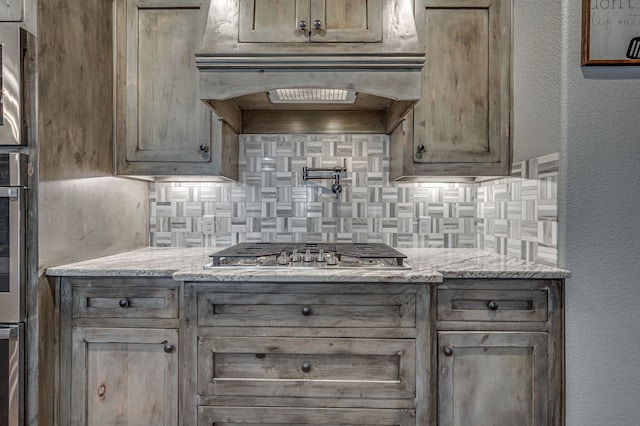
left=196, top=0, right=424, bottom=133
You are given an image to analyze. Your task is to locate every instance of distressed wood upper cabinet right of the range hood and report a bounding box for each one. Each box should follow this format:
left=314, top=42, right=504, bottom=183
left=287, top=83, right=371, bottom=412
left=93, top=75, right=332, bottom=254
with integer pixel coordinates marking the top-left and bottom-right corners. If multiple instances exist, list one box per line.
left=391, top=0, right=512, bottom=179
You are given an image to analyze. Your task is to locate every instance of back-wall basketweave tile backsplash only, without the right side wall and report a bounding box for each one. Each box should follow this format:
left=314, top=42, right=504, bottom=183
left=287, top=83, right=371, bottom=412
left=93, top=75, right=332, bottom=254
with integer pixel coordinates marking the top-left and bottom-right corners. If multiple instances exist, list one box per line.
left=150, top=135, right=476, bottom=247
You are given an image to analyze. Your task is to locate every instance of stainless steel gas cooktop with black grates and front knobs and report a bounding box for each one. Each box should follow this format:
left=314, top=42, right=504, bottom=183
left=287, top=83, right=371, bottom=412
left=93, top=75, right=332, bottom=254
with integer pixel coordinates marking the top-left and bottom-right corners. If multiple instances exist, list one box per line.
left=205, top=243, right=411, bottom=269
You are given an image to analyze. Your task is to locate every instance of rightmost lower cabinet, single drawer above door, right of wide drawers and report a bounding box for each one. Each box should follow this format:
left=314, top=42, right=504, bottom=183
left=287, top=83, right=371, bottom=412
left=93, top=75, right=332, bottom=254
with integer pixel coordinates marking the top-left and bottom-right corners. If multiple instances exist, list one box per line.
left=428, top=279, right=564, bottom=426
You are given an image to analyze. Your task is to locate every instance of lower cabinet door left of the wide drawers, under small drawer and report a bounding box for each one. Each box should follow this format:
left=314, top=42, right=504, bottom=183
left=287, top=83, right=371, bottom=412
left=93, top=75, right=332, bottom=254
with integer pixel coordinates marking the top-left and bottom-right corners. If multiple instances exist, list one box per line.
left=71, top=328, right=178, bottom=426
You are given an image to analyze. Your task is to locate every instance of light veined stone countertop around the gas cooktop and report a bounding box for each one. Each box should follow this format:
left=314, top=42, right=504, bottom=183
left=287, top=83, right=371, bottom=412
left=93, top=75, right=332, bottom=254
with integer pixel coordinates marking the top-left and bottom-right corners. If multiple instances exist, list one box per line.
left=47, top=247, right=570, bottom=283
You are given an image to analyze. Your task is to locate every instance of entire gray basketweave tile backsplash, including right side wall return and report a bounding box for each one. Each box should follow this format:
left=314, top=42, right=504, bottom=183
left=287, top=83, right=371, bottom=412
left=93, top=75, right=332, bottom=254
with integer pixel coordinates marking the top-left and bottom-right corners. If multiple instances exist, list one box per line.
left=150, top=135, right=557, bottom=264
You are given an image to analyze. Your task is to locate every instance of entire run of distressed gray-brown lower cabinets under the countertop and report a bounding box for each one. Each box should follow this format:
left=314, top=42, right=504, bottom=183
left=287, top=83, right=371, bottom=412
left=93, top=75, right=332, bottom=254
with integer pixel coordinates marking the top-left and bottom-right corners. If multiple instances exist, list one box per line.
left=56, top=277, right=564, bottom=426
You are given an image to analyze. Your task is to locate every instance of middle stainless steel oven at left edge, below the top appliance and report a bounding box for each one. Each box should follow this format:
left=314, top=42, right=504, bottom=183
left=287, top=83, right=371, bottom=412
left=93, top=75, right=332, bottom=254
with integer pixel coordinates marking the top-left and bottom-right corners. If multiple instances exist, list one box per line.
left=0, top=152, right=27, bottom=324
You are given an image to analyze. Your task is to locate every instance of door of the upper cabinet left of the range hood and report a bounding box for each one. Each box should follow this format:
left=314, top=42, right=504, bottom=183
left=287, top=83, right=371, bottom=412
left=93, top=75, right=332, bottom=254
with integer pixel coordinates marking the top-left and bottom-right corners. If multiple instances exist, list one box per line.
left=125, top=0, right=212, bottom=162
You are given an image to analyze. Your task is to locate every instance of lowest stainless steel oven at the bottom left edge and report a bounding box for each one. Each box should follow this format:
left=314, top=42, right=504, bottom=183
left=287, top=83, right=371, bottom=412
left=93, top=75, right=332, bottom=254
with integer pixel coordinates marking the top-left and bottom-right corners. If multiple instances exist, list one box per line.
left=0, top=324, right=24, bottom=426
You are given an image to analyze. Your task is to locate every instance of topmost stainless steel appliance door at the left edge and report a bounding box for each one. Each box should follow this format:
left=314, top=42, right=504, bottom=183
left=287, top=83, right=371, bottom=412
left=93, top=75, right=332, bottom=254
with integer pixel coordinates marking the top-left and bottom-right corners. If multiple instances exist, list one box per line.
left=0, top=22, right=26, bottom=145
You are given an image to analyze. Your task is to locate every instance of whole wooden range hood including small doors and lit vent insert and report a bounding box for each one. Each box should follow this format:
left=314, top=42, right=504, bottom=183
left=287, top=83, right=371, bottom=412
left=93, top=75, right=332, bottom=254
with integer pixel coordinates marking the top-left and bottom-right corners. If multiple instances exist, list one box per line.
left=196, top=0, right=424, bottom=133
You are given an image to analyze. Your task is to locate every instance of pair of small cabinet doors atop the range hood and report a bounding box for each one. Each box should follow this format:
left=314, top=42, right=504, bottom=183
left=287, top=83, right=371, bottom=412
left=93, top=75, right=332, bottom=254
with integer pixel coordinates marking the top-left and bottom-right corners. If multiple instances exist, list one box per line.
left=239, top=0, right=382, bottom=43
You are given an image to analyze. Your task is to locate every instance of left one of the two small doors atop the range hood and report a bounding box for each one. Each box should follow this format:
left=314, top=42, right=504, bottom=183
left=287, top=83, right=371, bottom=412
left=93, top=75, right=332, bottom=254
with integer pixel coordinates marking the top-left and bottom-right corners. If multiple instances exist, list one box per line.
left=238, top=0, right=311, bottom=43
